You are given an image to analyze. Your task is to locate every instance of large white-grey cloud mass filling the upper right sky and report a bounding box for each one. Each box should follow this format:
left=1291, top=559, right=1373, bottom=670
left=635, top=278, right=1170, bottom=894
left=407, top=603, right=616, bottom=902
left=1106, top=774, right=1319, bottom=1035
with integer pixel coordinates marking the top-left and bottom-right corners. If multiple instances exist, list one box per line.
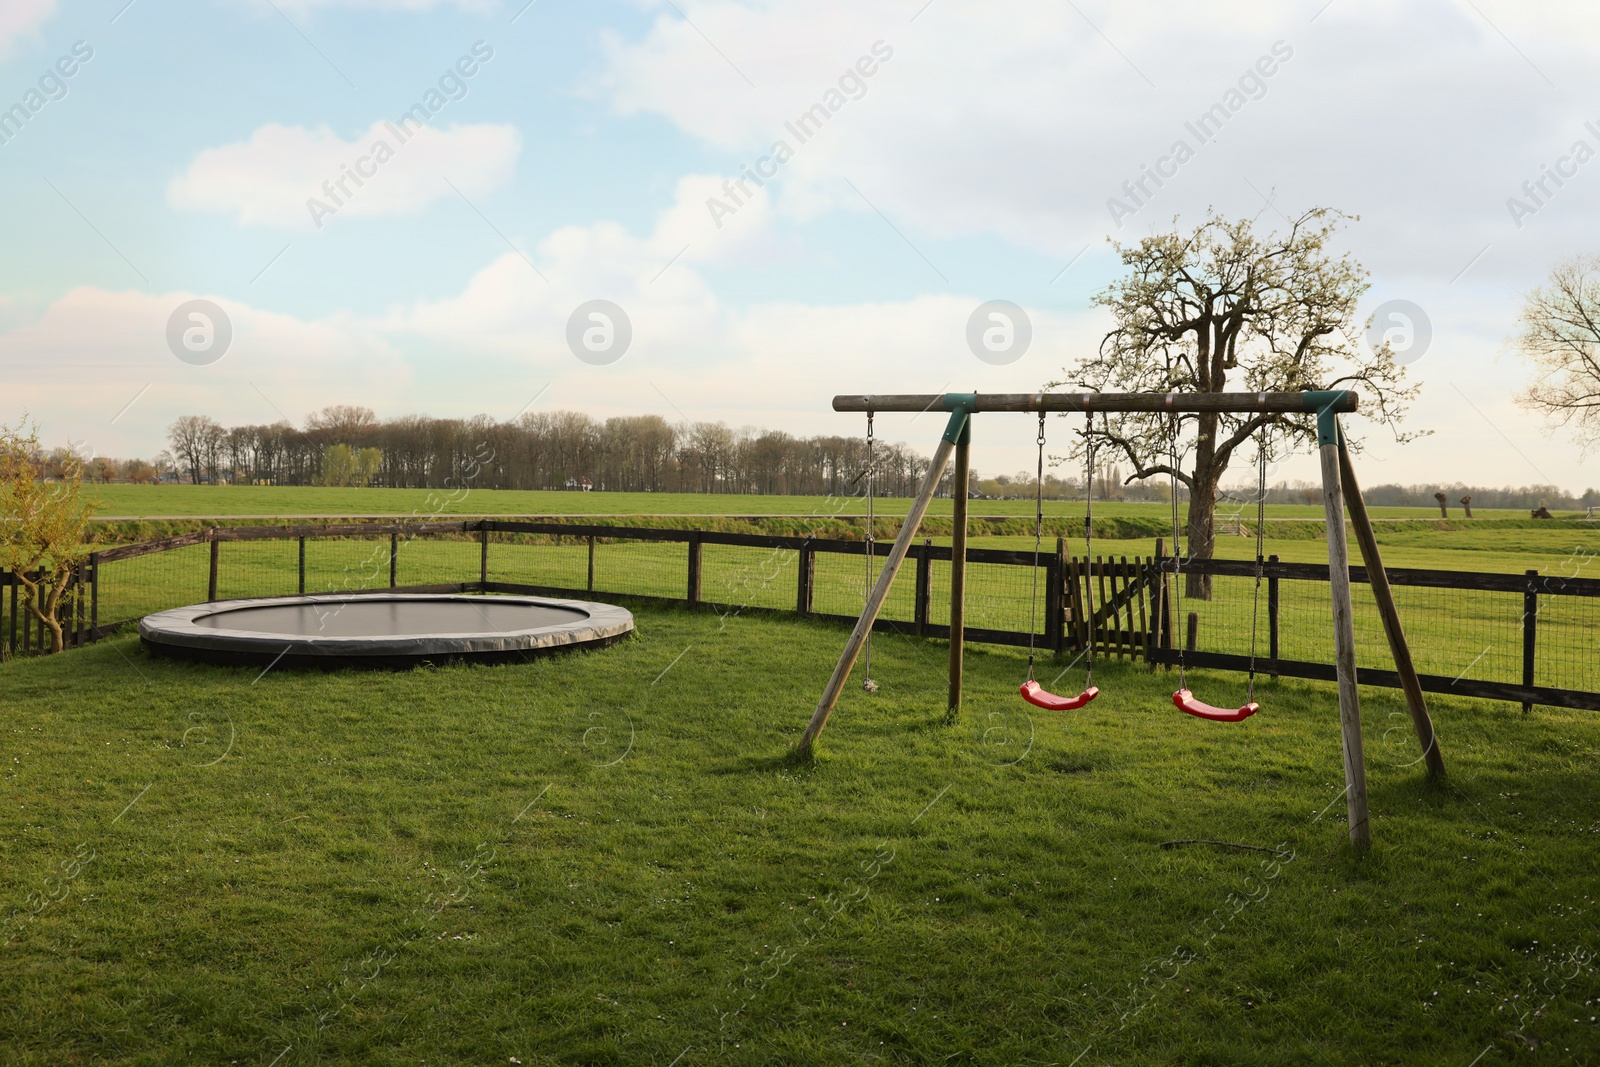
left=595, top=0, right=1600, bottom=278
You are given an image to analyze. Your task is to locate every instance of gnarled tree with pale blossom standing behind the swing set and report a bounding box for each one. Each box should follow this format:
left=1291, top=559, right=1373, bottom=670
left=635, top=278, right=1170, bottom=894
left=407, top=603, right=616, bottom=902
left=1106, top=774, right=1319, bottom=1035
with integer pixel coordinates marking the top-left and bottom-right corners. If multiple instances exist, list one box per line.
left=1053, top=208, right=1416, bottom=598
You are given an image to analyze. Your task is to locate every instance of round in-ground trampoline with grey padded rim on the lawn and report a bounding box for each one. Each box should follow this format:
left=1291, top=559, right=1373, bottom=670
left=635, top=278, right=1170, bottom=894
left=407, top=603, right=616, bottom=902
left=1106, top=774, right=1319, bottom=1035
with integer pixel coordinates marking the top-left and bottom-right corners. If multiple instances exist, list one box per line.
left=139, top=593, right=634, bottom=669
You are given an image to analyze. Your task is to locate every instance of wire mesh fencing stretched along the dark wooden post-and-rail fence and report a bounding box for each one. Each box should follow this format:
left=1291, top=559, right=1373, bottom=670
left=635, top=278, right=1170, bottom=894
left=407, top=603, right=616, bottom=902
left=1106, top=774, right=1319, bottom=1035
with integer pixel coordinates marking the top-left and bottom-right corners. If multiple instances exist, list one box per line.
left=28, top=520, right=1600, bottom=710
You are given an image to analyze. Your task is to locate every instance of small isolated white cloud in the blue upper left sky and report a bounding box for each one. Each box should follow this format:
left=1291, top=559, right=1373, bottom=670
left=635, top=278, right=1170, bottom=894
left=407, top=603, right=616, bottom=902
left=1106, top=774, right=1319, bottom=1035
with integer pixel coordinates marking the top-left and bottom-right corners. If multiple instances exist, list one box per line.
left=166, top=122, right=522, bottom=230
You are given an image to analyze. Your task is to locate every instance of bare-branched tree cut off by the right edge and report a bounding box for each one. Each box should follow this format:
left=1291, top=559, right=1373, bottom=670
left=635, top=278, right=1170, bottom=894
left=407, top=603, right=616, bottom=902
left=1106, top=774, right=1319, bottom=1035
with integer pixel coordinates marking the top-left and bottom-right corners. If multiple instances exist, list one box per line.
left=1515, top=258, right=1600, bottom=451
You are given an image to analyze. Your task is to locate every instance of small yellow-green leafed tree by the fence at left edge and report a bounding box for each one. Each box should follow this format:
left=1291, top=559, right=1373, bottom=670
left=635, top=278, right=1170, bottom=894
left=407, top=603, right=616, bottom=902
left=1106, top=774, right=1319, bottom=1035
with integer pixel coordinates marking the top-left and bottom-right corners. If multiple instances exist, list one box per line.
left=0, top=424, right=94, bottom=653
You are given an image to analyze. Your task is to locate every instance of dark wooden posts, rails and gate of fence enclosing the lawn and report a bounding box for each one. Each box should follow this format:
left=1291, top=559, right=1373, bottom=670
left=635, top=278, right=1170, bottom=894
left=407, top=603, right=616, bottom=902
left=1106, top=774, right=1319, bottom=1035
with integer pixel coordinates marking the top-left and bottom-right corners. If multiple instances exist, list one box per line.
left=9, top=518, right=1600, bottom=710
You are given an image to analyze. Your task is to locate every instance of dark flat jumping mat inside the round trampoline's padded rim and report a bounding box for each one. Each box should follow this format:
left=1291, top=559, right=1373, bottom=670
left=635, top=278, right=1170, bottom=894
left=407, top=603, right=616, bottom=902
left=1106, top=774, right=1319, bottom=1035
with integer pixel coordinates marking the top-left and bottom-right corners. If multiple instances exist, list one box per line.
left=194, top=597, right=589, bottom=637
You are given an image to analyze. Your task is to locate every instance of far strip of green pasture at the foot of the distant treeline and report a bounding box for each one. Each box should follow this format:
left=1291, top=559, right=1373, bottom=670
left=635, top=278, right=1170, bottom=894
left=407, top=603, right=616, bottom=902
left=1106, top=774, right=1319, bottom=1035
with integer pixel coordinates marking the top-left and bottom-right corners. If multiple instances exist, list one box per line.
left=90, top=485, right=1548, bottom=520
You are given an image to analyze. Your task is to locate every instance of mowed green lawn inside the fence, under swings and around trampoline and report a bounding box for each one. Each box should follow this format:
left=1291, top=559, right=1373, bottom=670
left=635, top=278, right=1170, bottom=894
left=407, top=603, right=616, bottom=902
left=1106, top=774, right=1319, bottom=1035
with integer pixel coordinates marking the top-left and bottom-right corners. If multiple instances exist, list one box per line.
left=0, top=608, right=1600, bottom=1067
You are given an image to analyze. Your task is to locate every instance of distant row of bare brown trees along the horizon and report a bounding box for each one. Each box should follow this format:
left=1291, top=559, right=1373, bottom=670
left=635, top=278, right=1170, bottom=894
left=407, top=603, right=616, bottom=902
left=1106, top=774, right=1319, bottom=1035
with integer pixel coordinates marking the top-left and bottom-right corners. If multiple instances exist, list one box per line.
left=40, top=405, right=1600, bottom=510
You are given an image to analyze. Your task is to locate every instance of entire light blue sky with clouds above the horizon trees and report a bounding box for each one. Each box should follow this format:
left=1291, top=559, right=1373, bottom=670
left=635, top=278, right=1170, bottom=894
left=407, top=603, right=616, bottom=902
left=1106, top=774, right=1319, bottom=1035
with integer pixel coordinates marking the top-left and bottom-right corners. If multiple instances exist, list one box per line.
left=0, top=0, right=1600, bottom=488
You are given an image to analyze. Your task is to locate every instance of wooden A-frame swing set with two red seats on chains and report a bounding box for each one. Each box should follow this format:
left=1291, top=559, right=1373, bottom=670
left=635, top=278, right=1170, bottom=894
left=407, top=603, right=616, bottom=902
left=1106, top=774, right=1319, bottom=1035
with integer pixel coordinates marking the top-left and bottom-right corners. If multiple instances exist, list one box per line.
left=798, top=389, right=1445, bottom=849
